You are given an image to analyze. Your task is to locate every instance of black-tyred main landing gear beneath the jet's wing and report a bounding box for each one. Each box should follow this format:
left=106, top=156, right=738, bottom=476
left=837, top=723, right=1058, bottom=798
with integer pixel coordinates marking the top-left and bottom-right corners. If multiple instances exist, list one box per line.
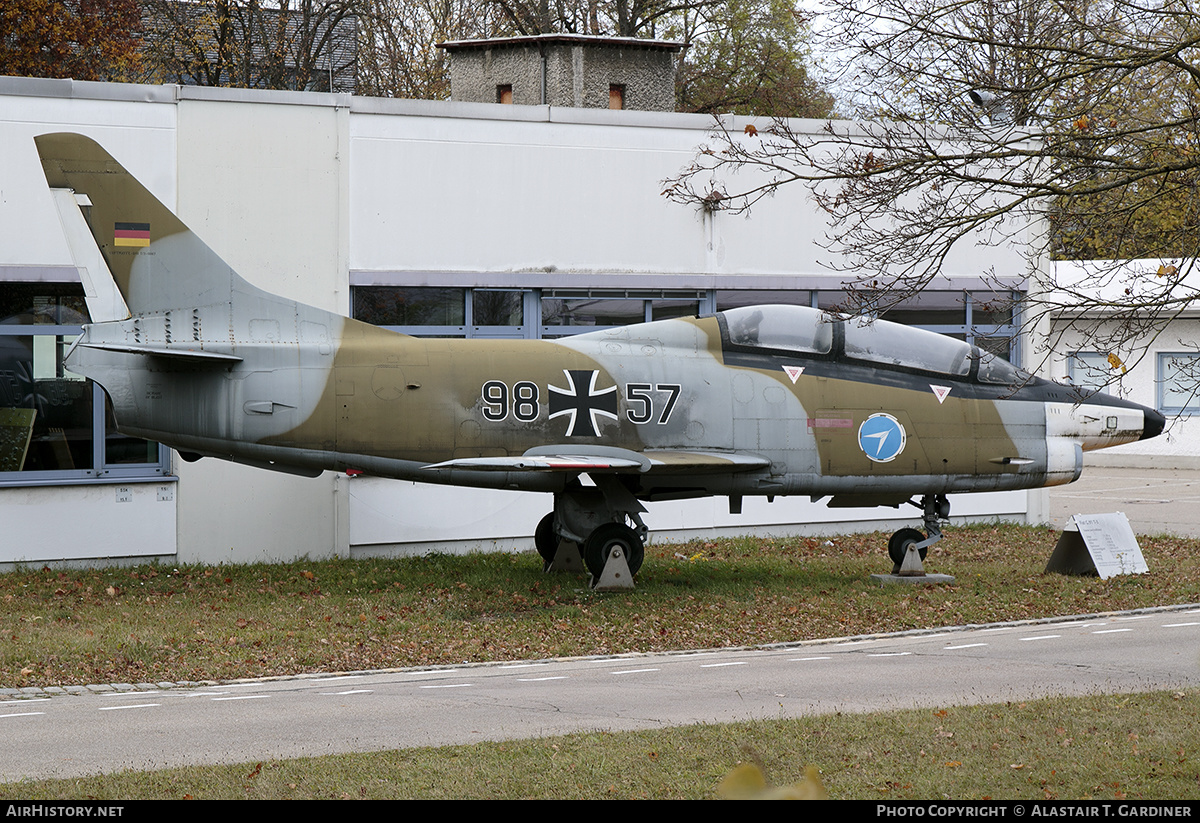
left=534, top=475, right=649, bottom=588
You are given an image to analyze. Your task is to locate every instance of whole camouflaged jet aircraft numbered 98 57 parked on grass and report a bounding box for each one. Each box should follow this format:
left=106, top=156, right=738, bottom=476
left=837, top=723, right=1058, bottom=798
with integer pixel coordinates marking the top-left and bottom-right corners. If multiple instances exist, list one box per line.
left=36, top=134, right=1164, bottom=577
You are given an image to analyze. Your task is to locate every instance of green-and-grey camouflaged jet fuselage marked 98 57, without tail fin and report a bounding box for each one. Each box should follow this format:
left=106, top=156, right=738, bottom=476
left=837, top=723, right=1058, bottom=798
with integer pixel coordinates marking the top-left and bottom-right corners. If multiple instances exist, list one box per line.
left=72, top=299, right=1153, bottom=504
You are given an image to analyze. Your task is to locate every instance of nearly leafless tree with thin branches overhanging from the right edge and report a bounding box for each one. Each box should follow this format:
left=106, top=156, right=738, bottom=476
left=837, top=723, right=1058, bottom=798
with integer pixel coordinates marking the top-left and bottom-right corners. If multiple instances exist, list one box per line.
left=665, top=0, right=1200, bottom=381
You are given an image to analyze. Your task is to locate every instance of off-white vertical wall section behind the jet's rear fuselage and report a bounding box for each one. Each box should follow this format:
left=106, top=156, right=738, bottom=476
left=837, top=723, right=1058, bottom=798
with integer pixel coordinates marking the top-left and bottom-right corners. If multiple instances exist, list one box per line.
left=168, top=88, right=349, bottom=563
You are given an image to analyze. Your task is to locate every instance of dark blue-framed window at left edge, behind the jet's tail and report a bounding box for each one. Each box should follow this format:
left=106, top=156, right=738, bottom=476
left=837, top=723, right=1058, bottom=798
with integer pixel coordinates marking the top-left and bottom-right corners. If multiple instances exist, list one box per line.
left=0, top=282, right=167, bottom=485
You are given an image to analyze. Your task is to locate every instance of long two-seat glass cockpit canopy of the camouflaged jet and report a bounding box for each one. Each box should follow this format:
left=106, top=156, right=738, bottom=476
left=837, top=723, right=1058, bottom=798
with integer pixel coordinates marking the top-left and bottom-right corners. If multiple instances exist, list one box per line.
left=721, top=306, right=1028, bottom=385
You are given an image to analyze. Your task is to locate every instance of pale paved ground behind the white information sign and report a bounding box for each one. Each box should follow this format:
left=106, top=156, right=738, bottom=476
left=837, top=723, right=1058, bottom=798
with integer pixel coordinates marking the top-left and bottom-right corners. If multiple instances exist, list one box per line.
left=1050, top=465, right=1200, bottom=537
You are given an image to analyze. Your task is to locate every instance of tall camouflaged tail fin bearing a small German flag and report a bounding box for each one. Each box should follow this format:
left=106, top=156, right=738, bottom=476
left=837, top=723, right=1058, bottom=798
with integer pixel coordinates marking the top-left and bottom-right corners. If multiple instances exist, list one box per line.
left=34, top=133, right=252, bottom=322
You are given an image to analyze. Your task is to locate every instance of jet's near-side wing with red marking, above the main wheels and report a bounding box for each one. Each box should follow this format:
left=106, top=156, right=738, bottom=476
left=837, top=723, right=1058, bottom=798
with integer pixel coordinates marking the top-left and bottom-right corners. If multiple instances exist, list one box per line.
left=425, top=445, right=770, bottom=474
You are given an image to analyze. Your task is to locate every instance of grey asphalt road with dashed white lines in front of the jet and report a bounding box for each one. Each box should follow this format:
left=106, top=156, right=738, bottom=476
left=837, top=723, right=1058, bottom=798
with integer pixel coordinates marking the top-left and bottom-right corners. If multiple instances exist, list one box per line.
left=0, top=606, right=1200, bottom=782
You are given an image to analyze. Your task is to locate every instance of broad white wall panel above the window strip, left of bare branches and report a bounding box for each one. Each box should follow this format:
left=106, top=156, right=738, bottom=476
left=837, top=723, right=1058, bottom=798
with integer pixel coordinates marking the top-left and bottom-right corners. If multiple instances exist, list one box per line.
left=350, top=98, right=1026, bottom=283
